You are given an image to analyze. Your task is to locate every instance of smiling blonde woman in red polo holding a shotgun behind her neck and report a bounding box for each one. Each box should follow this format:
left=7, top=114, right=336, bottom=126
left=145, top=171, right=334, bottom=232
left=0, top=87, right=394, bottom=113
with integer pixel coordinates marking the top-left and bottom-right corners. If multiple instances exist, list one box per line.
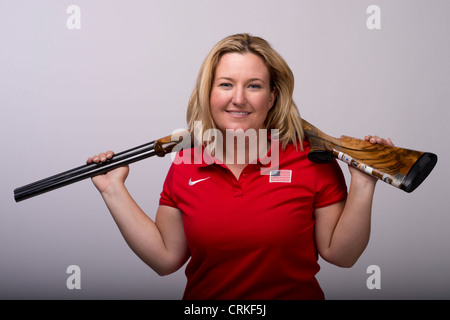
left=87, top=34, right=392, bottom=299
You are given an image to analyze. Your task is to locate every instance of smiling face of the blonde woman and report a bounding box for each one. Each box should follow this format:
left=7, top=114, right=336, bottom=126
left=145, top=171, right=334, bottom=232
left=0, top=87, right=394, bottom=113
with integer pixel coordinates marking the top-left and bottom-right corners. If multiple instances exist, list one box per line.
left=210, top=53, right=276, bottom=133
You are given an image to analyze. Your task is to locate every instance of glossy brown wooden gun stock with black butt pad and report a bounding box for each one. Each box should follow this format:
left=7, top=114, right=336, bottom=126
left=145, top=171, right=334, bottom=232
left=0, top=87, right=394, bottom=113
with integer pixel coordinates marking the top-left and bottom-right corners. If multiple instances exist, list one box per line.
left=302, top=120, right=437, bottom=192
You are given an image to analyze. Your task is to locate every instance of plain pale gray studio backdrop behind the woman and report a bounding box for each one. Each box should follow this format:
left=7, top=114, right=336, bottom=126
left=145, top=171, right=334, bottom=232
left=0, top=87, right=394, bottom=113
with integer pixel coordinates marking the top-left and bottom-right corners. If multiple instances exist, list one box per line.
left=0, top=0, right=450, bottom=299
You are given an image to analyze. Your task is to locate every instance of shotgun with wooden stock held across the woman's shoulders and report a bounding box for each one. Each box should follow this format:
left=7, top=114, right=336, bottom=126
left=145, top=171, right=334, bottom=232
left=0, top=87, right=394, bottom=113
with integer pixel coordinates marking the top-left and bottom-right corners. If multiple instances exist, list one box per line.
left=14, top=119, right=437, bottom=202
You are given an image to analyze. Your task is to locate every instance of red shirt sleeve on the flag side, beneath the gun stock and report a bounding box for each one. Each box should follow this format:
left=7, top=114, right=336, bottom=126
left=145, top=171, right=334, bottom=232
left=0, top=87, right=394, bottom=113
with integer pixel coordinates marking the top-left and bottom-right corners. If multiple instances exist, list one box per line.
left=314, top=160, right=347, bottom=209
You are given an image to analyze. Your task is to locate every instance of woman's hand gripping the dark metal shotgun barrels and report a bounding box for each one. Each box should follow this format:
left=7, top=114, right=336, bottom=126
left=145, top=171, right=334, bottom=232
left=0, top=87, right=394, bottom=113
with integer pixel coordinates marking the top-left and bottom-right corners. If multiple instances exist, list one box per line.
left=86, top=151, right=130, bottom=193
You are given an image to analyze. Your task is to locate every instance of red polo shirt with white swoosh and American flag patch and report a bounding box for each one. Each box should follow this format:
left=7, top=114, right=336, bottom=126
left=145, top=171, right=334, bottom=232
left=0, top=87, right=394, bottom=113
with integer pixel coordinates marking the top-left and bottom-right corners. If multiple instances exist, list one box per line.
left=160, top=142, right=347, bottom=299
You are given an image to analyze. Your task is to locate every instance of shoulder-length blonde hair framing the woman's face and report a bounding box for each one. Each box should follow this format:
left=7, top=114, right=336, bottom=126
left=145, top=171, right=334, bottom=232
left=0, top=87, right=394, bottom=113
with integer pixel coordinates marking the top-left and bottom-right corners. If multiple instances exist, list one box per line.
left=186, top=34, right=304, bottom=147
